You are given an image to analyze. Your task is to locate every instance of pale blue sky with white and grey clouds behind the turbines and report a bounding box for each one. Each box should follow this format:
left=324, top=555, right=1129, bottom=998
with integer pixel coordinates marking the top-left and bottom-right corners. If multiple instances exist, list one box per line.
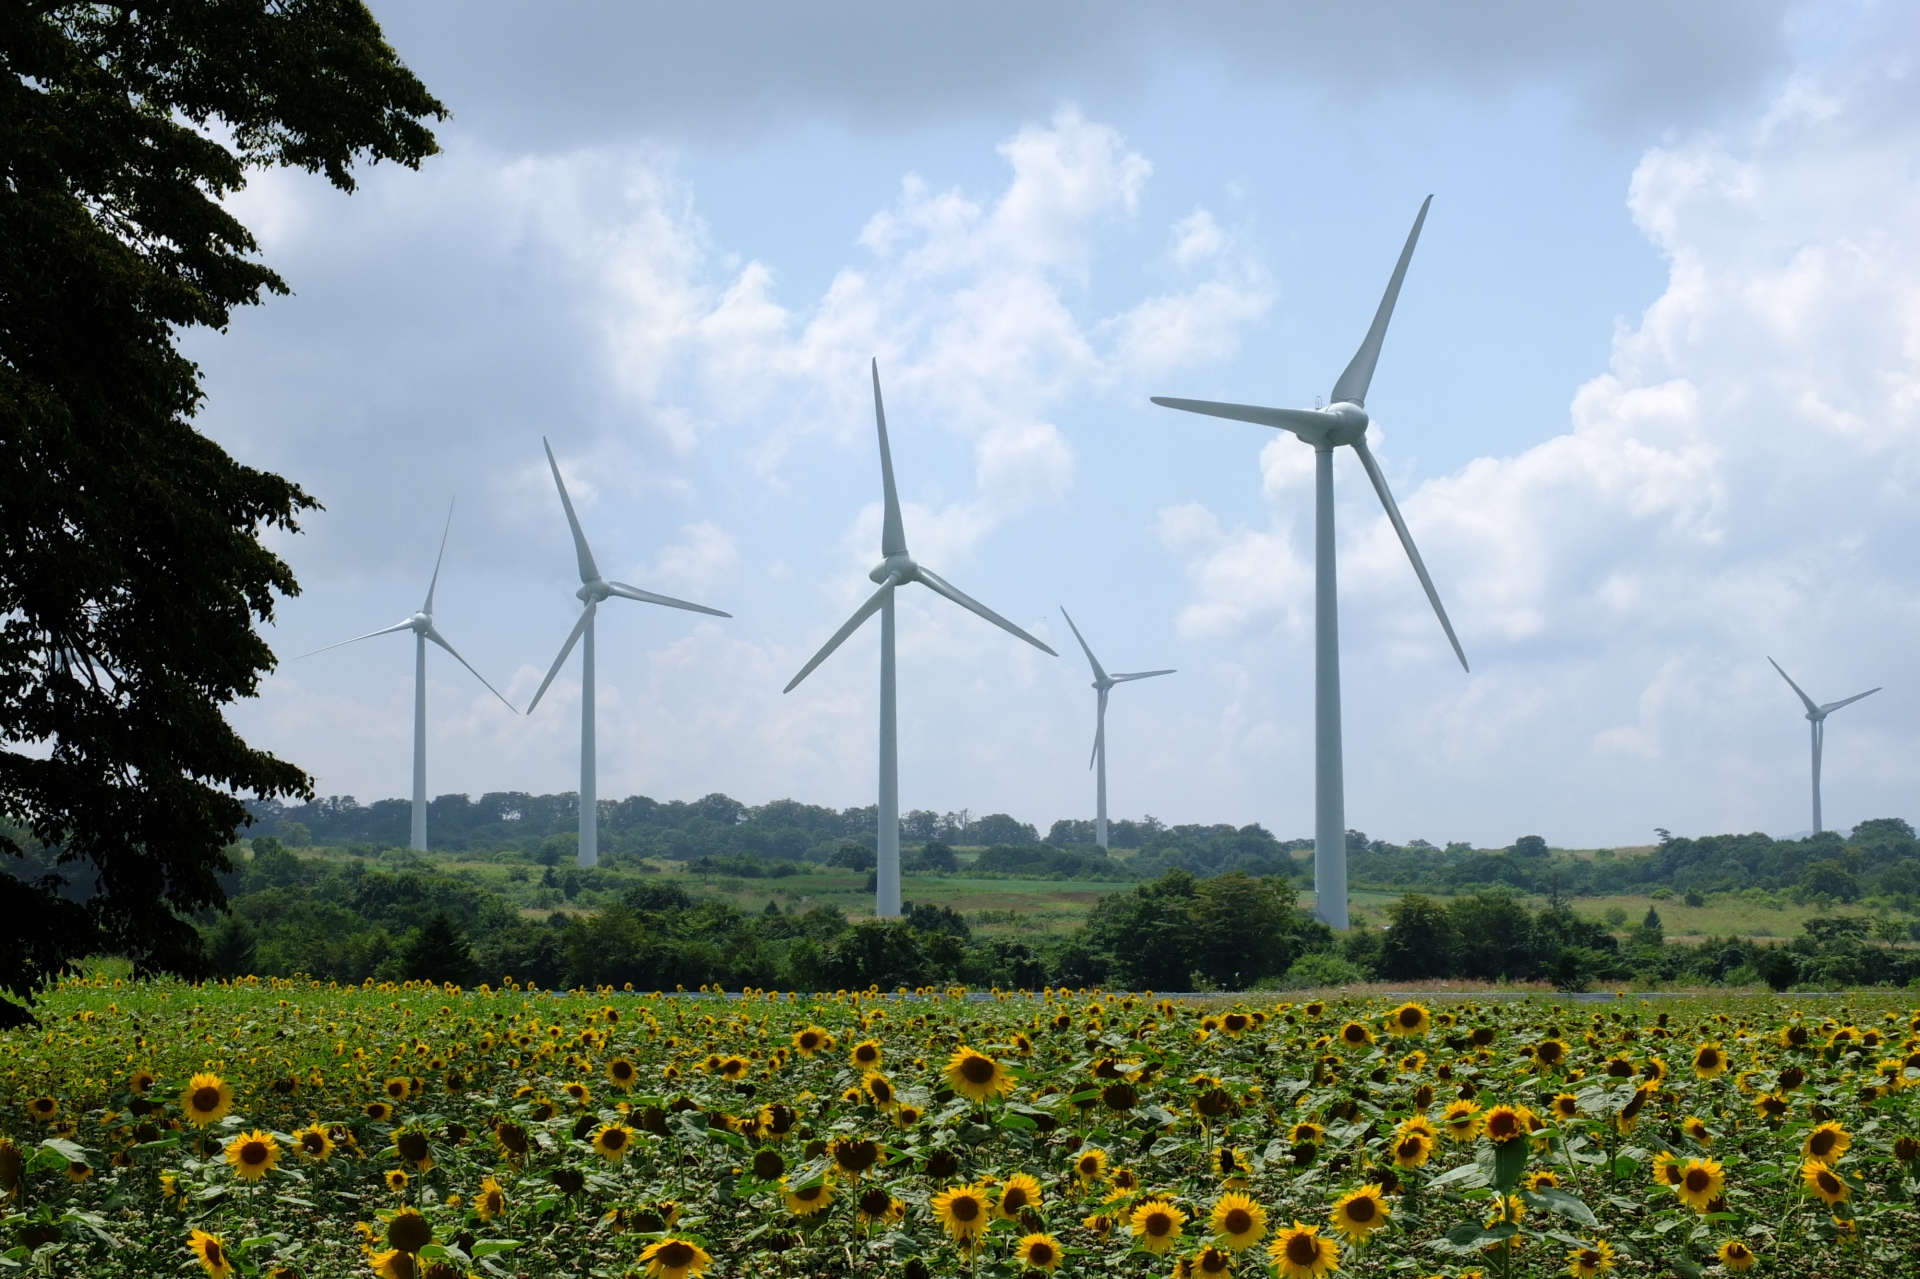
left=186, top=0, right=1920, bottom=847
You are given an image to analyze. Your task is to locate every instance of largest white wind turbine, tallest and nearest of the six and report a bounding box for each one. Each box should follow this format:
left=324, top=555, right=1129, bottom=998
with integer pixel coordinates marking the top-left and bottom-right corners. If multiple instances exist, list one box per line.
left=1152, top=196, right=1469, bottom=929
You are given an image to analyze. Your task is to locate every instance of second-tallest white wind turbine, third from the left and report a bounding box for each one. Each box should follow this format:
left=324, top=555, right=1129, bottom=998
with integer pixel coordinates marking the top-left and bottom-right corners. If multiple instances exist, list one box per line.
left=780, top=359, right=1060, bottom=918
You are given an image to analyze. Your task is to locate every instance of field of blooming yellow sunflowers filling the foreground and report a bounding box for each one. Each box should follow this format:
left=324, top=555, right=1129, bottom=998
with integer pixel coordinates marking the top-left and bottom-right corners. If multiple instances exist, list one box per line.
left=0, top=977, right=1920, bottom=1279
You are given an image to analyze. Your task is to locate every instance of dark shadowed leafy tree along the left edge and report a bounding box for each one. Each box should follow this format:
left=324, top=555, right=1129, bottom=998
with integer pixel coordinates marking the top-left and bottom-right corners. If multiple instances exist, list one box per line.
left=0, top=0, right=445, bottom=1024
